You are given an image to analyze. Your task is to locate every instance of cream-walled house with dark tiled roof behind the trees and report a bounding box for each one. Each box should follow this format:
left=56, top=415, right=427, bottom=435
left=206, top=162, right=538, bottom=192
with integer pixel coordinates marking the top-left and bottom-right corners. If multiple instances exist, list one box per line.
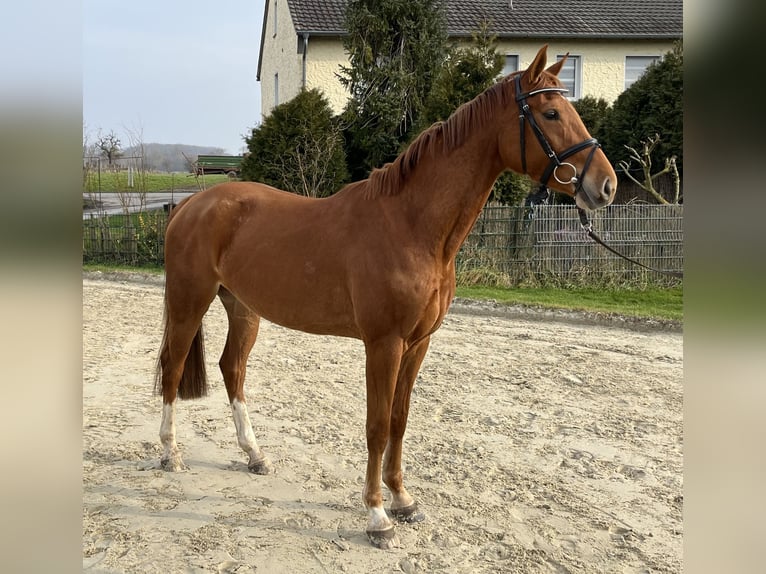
left=257, top=0, right=683, bottom=116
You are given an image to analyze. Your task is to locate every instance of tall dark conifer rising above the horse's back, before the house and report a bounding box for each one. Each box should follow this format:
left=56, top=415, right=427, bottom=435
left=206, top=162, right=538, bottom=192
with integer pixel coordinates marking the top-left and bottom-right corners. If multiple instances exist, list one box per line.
left=340, top=0, right=447, bottom=180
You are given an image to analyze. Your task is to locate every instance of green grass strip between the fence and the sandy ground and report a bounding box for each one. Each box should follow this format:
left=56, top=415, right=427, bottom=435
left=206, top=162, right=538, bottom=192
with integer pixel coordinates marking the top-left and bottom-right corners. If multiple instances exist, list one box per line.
left=83, top=265, right=683, bottom=322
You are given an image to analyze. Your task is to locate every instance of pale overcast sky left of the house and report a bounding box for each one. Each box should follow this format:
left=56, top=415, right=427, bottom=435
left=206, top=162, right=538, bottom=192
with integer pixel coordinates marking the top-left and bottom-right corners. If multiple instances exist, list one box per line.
left=82, top=0, right=264, bottom=154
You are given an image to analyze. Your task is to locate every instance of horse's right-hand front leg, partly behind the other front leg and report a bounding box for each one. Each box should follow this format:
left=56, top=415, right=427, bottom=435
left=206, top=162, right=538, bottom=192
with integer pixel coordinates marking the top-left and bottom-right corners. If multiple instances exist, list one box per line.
left=383, top=337, right=430, bottom=524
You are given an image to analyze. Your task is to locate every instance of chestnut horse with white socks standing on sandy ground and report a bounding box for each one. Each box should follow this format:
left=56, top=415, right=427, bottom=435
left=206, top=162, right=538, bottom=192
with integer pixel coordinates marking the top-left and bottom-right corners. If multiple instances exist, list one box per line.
left=156, top=46, right=617, bottom=548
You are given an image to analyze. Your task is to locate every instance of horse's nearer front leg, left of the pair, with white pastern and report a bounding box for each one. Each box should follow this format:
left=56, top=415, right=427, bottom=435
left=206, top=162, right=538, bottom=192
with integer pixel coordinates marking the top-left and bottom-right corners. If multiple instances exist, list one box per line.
left=362, top=337, right=403, bottom=549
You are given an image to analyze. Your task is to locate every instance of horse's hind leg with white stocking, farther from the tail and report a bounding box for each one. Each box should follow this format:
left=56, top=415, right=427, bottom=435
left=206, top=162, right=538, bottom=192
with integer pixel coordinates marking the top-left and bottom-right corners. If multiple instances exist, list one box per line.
left=218, top=287, right=273, bottom=474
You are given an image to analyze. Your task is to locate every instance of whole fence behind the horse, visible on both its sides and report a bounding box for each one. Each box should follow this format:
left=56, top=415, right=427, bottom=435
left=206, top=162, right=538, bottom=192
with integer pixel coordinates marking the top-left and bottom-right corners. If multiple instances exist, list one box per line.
left=83, top=204, right=683, bottom=286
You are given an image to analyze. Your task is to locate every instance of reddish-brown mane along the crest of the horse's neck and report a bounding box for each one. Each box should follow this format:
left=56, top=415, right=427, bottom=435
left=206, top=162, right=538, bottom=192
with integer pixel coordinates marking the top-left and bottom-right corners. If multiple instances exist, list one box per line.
left=366, top=72, right=521, bottom=197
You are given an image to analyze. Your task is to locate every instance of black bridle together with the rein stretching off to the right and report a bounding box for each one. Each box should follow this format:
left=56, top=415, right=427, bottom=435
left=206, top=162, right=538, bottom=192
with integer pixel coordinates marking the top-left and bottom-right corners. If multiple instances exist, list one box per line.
left=515, top=74, right=683, bottom=277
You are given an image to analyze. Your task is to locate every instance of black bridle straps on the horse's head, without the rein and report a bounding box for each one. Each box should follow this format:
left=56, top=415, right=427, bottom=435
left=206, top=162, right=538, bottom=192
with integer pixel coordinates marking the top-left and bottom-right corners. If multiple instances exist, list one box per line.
left=514, top=74, right=601, bottom=195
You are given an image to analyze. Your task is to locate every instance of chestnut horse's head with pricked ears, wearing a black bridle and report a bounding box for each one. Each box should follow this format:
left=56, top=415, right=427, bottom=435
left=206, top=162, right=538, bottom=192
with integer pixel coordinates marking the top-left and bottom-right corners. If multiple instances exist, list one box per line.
left=500, top=45, right=617, bottom=210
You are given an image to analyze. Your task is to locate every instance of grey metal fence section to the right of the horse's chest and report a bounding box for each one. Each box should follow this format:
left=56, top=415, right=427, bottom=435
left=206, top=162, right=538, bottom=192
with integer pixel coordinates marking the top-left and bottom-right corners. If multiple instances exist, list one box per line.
left=456, top=204, right=683, bottom=286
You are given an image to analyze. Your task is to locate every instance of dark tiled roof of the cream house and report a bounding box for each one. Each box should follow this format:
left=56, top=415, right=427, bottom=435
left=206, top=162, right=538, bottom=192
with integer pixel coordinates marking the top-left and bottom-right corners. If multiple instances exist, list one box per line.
left=287, top=0, right=683, bottom=39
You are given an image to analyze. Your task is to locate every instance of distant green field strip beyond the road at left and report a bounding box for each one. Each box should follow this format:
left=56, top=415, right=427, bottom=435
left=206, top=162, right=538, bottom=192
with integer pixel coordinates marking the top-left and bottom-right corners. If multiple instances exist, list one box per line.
left=83, top=171, right=234, bottom=193
